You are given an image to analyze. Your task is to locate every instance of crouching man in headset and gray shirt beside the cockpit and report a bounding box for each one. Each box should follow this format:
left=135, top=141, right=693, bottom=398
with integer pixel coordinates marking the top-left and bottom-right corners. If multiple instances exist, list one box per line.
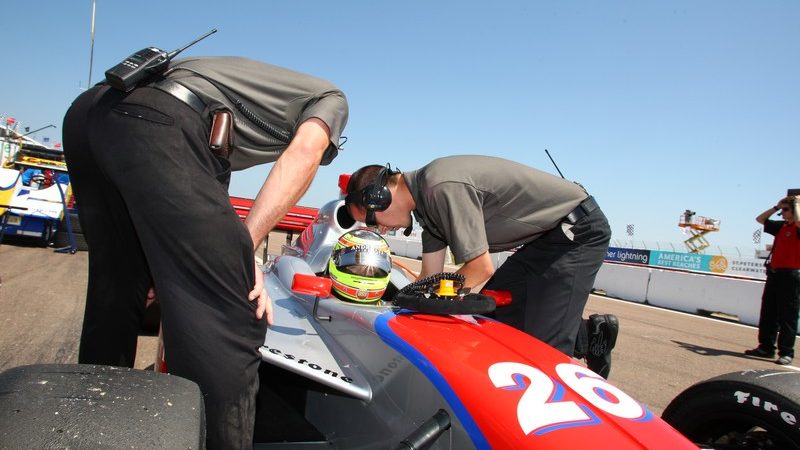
left=345, top=156, right=619, bottom=377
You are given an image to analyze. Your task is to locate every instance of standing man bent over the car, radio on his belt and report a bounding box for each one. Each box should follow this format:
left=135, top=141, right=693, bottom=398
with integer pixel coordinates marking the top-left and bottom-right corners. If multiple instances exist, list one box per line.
left=64, top=57, right=348, bottom=449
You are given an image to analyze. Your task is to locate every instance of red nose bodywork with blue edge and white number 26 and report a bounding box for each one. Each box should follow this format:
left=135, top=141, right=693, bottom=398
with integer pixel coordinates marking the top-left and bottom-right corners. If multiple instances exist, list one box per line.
left=376, top=313, right=697, bottom=450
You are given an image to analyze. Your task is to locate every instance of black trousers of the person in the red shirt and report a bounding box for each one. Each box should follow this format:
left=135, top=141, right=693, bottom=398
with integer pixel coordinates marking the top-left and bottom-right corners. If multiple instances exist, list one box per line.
left=758, top=271, right=800, bottom=357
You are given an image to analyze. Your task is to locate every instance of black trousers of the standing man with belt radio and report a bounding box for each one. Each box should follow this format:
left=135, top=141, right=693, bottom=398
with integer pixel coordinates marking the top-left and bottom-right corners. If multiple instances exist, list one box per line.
left=63, top=83, right=266, bottom=448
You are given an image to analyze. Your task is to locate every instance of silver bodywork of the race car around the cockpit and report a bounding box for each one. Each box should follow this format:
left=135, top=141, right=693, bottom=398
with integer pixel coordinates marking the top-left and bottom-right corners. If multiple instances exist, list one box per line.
left=261, top=200, right=474, bottom=449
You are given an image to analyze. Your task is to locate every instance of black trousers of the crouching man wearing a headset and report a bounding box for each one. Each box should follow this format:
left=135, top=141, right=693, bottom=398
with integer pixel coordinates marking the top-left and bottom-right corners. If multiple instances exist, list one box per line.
left=485, top=208, right=611, bottom=356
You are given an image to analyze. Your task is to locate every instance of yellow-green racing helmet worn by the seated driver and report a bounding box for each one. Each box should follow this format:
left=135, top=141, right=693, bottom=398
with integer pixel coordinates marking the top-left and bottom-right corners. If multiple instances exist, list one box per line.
left=328, top=229, right=392, bottom=303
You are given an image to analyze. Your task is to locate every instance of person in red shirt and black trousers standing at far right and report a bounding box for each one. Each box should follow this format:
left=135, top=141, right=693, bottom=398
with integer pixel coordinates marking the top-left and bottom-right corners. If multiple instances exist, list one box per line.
left=744, top=195, right=800, bottom=365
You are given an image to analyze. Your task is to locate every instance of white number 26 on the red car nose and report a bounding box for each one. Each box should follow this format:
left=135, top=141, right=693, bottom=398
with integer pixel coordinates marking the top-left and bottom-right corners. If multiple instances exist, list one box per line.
left=489, top=362, right=651, bottom=435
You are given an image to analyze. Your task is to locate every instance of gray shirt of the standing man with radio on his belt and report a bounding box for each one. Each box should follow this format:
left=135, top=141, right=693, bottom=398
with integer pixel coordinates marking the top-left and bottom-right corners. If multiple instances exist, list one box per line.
left=166, top=56, right=348, bottom=170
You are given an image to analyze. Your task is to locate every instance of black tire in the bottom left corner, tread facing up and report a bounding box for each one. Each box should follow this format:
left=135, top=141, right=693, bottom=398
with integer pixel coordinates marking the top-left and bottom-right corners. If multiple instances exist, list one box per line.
left=0, top=364, right=206, bottom=449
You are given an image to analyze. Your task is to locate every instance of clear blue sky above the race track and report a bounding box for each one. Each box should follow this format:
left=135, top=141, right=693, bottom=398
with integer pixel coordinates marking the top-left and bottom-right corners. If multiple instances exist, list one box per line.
left=0, top=0, right=800, bottom=251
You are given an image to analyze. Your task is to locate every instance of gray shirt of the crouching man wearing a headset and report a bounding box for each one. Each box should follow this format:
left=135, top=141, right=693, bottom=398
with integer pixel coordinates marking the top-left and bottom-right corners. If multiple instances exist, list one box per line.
left=403, top=156, right=588, bottom=263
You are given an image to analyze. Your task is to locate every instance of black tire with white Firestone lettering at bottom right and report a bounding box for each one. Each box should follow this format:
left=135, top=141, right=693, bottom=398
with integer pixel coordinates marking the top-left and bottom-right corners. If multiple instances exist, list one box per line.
left=662, top=370, right=800, bottom=450
